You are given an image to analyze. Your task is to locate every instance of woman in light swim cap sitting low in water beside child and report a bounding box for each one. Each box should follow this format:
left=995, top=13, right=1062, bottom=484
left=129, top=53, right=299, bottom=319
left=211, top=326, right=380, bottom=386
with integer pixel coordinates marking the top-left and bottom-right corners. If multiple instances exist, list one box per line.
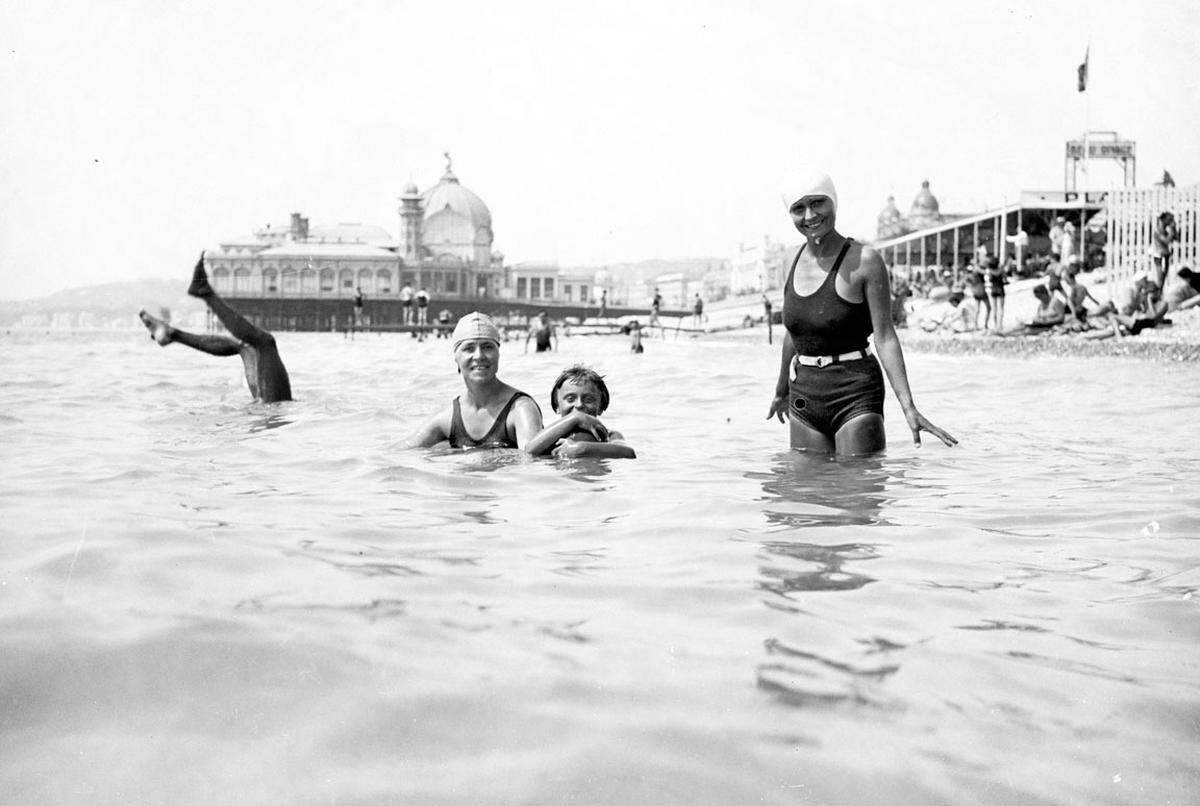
left=406, top=312, right=542, bottom=449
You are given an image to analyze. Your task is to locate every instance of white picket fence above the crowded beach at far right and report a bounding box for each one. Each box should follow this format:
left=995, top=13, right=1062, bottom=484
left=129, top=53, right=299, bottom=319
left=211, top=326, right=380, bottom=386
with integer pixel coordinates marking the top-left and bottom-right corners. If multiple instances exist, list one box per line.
left=1105, top=185, right=1200, bottom=282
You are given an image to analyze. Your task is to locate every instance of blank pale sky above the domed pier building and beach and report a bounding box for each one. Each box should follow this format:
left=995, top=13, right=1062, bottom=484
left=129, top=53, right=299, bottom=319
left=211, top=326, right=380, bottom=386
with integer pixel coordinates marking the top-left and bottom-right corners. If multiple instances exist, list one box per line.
left=0, top=0, right=1200, bottom=299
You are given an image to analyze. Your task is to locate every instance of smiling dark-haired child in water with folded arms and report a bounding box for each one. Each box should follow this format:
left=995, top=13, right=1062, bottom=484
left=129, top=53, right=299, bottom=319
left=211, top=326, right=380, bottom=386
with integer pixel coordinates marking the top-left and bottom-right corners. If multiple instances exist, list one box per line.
left=526, top=365, right=637, bottom=459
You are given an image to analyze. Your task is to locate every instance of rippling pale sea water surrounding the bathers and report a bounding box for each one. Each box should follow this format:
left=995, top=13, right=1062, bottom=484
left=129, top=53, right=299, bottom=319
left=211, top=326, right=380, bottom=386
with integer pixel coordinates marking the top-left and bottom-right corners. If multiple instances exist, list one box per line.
left=0, top=331, right=1200, bottom=805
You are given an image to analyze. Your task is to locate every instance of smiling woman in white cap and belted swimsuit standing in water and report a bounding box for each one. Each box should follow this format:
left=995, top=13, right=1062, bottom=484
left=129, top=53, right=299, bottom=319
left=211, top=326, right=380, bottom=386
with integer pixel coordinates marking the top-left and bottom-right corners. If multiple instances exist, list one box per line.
left=767, top=175, right=958, bottom=455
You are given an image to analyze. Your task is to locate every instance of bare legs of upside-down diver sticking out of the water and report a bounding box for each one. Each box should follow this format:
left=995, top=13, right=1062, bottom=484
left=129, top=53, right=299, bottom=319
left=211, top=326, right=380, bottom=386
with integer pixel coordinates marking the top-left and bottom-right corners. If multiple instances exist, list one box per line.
left=138, top=252, right=292, bottom=403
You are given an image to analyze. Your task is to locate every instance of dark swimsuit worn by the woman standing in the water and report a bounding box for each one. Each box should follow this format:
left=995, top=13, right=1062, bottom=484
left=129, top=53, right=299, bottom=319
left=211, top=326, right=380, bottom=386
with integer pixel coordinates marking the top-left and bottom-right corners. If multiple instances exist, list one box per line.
left=784, top=239, right=884, bottom=439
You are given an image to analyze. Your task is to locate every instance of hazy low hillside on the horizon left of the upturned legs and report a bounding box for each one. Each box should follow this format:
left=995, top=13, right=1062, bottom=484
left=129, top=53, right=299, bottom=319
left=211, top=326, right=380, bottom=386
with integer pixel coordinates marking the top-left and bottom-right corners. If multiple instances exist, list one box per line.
left=0, top=279, right=204, bottom=326
